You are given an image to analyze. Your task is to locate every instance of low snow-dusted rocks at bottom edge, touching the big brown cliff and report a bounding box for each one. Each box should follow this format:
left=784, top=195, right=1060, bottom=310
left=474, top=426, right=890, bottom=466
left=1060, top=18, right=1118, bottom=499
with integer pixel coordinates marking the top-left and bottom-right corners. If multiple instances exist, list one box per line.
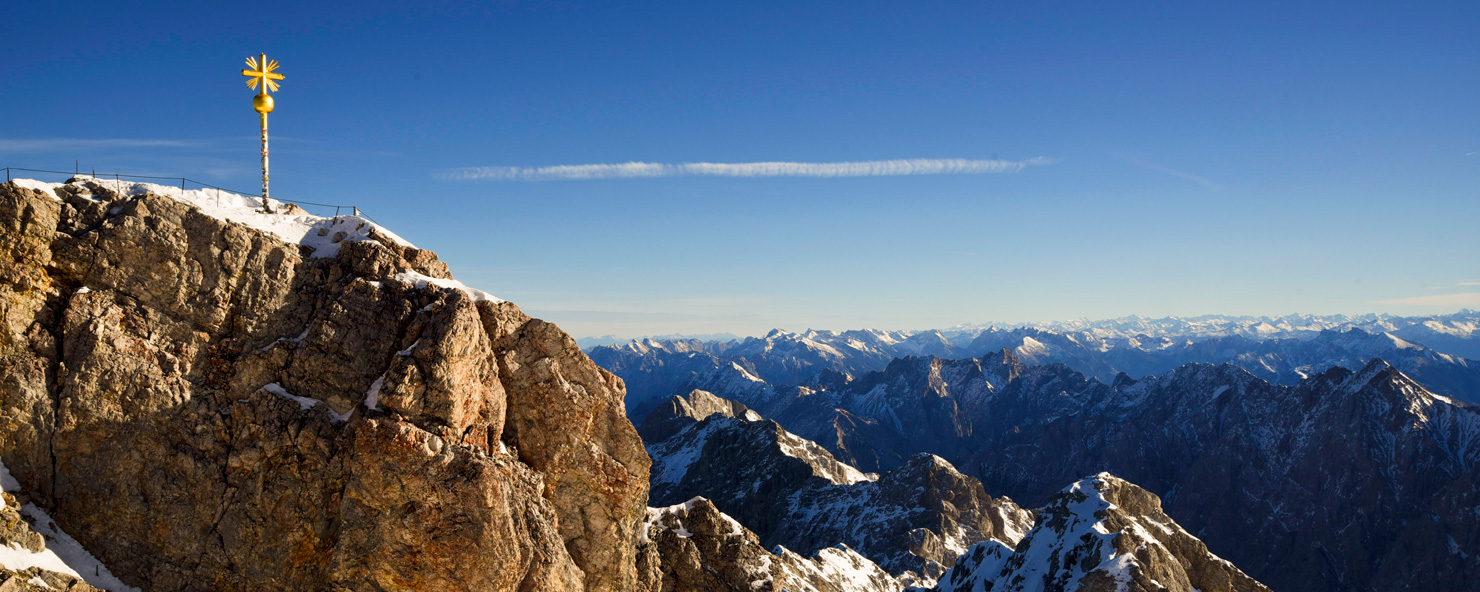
left=638, top=497, right=904, bottom=592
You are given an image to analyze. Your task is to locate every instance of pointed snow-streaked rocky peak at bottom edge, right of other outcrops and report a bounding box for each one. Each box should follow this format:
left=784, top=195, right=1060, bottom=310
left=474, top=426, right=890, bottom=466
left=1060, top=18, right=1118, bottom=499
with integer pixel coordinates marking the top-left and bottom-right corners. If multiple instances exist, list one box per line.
left=934, top=474, right=1268, bottom=592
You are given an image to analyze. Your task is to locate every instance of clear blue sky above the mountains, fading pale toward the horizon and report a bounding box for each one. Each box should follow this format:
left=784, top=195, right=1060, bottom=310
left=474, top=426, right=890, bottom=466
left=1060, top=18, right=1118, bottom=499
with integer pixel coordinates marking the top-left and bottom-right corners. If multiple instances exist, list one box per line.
left=0, top=1, right=1480, bottom=336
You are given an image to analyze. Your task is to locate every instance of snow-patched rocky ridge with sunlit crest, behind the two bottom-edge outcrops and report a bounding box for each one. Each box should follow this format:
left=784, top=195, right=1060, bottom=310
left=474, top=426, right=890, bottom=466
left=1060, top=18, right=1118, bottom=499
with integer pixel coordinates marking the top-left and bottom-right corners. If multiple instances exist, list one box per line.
left=644, top=391, right=1033, bottom=582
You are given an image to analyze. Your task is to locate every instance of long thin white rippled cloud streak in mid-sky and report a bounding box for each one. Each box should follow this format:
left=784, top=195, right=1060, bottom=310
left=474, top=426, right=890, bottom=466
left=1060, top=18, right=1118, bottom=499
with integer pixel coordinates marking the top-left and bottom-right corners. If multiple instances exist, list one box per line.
left=434, top=157, right=1054, bottom=181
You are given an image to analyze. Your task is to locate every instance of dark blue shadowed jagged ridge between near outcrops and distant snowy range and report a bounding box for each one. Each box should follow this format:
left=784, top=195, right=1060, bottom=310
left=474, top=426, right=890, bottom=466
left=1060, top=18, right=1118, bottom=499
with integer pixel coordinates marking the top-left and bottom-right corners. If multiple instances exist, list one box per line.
left=683, top=351, right=1480, bottom=589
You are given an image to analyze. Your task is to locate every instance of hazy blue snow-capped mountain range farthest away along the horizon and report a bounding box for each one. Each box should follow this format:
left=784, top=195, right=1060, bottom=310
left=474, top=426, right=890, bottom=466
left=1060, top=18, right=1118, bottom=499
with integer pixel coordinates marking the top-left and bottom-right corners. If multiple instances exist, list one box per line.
left=588, top=311, right=1480, bottom=420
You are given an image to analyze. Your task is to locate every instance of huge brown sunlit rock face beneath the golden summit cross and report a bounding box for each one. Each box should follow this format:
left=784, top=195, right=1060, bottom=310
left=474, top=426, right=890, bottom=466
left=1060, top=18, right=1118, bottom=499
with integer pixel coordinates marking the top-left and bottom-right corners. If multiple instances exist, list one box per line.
left=0, top=184, right=648, bottom=591
